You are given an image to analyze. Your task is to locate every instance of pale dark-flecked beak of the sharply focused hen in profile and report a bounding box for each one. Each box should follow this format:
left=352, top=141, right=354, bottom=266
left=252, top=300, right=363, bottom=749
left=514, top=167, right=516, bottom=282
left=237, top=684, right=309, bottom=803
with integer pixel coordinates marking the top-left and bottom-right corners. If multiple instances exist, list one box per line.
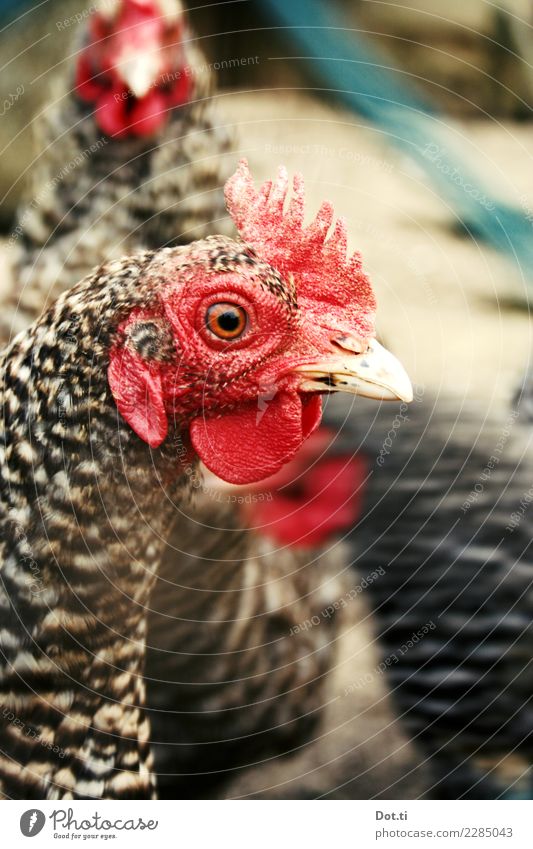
left=294, top=339, right=413, bottom=403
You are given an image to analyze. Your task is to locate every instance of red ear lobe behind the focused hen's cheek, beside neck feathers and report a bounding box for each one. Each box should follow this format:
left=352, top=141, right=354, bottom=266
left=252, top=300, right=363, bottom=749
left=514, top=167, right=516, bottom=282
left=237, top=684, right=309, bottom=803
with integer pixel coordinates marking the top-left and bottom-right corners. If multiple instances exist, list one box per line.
left=107, top=349, right=168, bottom=448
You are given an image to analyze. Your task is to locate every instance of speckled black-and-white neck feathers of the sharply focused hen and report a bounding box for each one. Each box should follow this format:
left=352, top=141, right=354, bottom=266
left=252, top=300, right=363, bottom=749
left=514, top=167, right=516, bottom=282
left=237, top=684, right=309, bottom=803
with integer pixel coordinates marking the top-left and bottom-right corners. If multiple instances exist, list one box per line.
left=0, top=254, right=189, bottom=799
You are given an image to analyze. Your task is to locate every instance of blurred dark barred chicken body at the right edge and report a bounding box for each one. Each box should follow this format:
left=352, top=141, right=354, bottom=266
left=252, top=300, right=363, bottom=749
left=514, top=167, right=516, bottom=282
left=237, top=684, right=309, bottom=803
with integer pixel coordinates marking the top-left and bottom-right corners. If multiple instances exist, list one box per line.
left=316, top=388, right=533, bottom=798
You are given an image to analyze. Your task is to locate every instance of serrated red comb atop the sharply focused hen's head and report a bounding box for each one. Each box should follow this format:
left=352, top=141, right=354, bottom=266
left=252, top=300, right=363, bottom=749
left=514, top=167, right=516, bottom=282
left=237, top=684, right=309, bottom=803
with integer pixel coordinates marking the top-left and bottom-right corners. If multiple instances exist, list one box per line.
left=225, top=159, right=376, bottom=336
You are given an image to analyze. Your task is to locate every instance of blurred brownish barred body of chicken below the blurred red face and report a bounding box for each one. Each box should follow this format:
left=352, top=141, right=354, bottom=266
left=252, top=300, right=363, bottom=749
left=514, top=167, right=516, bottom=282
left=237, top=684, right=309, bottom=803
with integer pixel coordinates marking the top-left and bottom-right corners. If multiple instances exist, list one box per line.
left=146, top=504, right=347, bottom=798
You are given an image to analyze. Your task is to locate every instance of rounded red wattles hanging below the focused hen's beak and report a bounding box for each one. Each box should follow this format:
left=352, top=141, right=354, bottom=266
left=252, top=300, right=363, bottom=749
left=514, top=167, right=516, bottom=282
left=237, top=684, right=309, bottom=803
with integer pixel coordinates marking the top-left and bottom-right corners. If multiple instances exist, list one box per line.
left=190, top=392, right=321, bottom=484
